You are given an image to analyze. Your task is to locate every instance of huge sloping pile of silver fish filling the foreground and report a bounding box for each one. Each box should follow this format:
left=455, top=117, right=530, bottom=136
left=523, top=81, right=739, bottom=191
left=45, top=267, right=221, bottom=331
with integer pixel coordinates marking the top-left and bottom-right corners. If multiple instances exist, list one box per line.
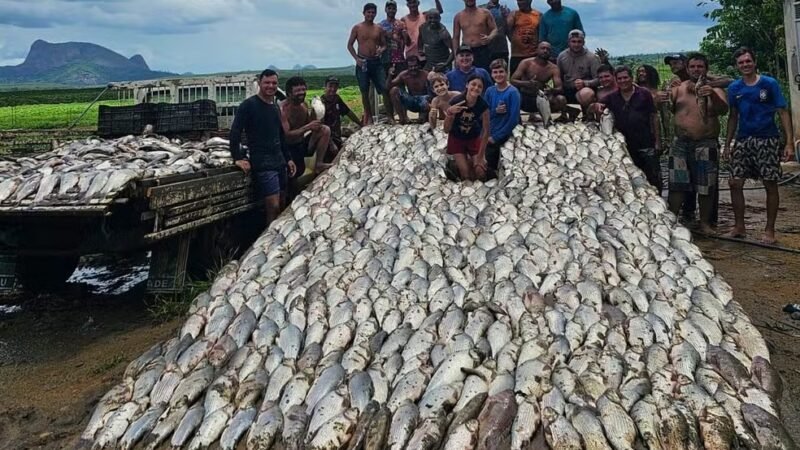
left=82, top=124, right=795, bottom=450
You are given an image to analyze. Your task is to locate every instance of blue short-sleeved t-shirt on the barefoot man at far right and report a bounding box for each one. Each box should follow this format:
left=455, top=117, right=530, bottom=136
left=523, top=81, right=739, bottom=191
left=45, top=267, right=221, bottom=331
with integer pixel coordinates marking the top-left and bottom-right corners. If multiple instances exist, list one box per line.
left=728, top=75, right=786, bottom=139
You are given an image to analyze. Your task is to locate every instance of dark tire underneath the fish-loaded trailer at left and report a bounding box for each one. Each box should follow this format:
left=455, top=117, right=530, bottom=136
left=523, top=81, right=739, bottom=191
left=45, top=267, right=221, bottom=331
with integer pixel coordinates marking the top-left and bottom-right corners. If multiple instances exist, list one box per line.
left=17, top=255, right=80, bottom=292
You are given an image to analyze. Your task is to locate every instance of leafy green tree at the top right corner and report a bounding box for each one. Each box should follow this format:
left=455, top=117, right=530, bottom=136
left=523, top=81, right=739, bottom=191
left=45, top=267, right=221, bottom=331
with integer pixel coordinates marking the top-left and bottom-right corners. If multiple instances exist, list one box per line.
left=698, top=0, right=788, bottom=82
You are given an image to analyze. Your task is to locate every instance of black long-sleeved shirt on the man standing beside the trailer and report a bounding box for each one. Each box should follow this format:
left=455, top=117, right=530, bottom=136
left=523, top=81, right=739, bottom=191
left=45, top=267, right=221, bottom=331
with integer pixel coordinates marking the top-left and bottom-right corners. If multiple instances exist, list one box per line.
left=230, top=95, right=291, bottom=171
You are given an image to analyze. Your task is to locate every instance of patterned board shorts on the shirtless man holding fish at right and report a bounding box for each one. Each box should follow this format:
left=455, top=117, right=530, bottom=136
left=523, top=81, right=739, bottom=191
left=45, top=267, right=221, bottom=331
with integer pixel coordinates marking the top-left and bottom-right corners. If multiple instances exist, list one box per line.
left=669, top=138, right=719, bottom=195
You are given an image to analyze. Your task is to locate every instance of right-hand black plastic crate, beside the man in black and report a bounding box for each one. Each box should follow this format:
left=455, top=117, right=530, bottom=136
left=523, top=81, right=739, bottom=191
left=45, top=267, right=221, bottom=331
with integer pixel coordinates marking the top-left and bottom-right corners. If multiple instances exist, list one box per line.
left=155, top=100, right=219, bottom=134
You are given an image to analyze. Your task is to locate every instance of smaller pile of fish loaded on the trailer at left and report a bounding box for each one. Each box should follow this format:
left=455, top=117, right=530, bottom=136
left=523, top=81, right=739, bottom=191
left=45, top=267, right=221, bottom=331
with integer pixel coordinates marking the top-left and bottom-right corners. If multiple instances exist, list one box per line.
left=0, top=136, right=233, bottom=206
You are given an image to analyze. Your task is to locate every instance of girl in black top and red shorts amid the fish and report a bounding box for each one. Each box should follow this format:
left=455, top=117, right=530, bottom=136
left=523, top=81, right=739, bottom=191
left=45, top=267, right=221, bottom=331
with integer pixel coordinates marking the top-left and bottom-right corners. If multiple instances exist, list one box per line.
left=444, top=75, right=490, bottom=181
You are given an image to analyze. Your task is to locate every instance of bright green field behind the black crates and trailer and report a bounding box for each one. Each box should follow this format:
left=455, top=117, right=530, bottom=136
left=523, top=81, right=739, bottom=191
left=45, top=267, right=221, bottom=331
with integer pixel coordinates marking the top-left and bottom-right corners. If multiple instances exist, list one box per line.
left=0, top=86, right=363, bottom=130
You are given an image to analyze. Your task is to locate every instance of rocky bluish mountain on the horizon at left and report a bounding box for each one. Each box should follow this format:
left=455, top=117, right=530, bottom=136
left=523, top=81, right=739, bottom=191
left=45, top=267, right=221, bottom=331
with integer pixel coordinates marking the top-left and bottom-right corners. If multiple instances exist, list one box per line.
left=0, top=40, right=174, bottom=86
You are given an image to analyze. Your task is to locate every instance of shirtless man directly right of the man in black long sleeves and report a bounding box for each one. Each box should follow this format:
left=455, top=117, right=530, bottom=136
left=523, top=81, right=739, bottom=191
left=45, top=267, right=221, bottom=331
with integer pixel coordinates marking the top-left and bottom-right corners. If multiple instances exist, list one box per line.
left=281, top=77, right=331, bottom=185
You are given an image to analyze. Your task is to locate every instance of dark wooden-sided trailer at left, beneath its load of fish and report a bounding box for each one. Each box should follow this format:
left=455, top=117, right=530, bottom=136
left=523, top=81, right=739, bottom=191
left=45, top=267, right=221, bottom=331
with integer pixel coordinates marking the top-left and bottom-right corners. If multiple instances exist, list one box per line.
left=0, top=166, right=261, bottom=292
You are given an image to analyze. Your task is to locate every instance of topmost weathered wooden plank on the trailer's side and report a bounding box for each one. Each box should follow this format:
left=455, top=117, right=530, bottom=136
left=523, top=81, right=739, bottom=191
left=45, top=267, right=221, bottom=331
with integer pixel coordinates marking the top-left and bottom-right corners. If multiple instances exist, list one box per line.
left=147, top=172, right=250, bottom=209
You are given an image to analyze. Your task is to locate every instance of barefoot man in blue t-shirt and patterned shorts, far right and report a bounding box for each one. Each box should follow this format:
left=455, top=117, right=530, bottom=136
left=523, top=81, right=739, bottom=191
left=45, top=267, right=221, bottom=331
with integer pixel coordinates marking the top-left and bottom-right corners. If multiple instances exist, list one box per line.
left=724, top=48, right=794, bottom=244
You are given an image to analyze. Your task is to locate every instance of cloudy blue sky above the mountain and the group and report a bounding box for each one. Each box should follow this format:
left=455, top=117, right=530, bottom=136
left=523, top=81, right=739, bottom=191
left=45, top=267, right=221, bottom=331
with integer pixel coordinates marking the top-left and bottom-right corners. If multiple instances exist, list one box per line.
left=0, top=0, right=712, bottom=73
